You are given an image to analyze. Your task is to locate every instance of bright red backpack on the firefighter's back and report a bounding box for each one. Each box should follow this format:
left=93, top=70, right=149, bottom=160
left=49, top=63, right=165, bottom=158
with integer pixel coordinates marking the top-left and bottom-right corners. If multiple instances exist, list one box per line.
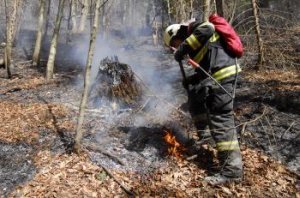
left=209, top=14, right=244, bottom=58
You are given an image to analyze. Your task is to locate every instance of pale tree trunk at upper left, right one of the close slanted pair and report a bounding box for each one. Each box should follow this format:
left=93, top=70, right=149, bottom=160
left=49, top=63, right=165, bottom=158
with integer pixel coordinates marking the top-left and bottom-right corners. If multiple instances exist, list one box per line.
left=46, top=0, right=65, bottom=80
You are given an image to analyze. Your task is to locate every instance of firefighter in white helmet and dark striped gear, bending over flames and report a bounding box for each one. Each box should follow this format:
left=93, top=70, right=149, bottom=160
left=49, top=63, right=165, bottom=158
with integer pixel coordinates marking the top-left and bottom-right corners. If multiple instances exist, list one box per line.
left=163, top=21, right=243, bottom=185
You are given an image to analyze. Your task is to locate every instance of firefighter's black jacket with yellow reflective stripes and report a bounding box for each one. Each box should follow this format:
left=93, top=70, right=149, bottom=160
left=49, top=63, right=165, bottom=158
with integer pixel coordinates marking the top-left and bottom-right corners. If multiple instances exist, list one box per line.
left=178, top=22, right=241, bottom=81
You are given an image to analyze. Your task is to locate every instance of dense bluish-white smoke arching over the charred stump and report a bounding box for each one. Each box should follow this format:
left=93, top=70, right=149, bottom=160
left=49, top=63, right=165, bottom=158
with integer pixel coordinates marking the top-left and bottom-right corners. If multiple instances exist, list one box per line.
left=71, top=33, right=182, bottom=126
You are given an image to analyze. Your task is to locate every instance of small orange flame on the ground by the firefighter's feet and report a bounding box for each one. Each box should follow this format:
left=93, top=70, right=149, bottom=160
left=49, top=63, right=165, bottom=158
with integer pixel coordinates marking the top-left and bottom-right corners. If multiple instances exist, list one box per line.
left=164, top=131, right=185, bottom=159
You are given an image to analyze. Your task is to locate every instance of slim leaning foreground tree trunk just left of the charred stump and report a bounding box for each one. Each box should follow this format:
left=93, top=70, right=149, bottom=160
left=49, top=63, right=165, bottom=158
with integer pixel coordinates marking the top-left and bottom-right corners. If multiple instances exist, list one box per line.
left=74, top=0, right=101, bottom=153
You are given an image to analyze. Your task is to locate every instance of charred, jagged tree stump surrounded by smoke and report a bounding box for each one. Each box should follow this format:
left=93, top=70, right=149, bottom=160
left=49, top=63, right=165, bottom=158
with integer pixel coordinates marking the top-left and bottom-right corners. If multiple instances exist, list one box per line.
left=90, top=56, right=142, bottom=108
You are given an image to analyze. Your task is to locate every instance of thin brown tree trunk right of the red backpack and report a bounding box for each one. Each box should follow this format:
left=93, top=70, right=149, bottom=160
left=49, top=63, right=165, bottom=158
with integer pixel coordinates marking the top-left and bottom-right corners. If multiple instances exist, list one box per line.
left=252, top=0, right=264, bottom=69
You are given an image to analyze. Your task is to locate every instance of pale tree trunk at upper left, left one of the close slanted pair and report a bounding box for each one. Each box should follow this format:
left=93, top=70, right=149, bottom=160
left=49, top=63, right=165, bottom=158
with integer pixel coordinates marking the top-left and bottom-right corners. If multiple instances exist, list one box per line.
left=32, top=0, right=46, bottom=66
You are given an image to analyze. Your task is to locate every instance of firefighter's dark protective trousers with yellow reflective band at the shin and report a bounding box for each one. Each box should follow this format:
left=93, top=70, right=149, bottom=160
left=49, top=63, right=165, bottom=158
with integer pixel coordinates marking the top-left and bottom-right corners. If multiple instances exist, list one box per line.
left=188, top=80, right=243, bottom=177
